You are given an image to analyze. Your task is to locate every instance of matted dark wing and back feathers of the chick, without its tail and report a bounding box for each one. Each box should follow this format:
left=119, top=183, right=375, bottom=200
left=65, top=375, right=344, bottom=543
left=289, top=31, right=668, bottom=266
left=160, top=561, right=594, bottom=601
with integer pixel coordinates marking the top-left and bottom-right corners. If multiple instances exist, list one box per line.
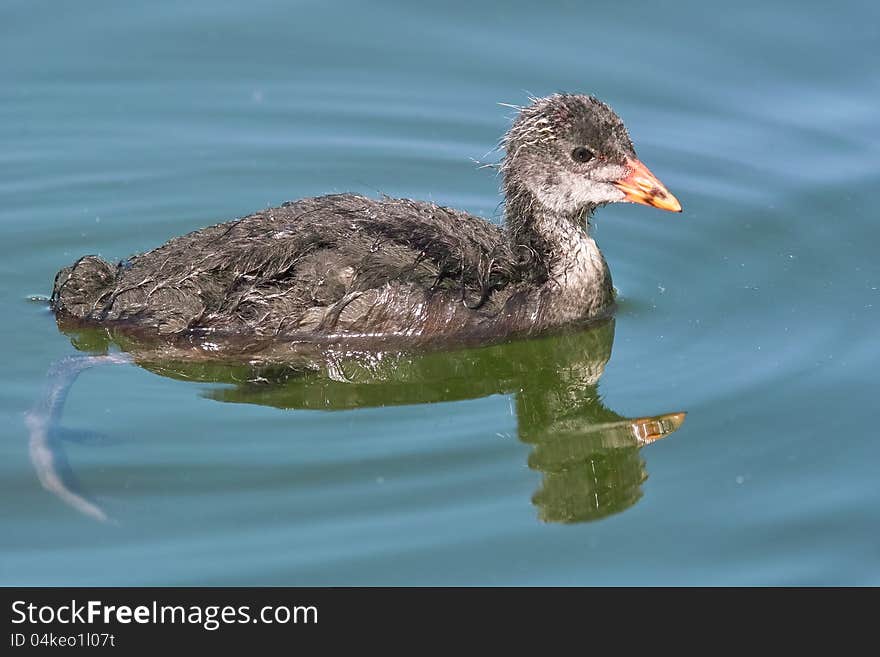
left=86, top=194, right=512, bottom=333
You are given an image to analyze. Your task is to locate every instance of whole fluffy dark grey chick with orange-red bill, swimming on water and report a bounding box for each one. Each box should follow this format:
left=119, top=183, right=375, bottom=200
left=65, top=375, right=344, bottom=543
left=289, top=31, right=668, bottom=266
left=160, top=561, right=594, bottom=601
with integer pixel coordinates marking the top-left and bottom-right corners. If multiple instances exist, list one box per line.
left=50, top=93, right=682, bottom=351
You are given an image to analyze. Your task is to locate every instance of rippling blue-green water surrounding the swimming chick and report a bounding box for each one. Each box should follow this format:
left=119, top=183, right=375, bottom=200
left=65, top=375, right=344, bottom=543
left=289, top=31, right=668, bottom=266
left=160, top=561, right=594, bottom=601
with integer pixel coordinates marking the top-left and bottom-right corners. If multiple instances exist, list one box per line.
left=0, top=0, right=880, bottom=585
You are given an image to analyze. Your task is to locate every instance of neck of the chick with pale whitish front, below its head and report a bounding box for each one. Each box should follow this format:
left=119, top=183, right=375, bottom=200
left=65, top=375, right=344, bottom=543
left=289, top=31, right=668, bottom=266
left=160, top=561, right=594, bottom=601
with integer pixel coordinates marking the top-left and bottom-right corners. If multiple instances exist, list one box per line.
left=505, top=186, right=614, bottom=319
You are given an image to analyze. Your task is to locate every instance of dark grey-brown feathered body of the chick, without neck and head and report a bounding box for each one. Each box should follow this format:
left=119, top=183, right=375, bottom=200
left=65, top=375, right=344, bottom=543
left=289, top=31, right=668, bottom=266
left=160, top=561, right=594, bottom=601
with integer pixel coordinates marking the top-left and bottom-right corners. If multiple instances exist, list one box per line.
left=52, top=194, right=608, bottom=342
